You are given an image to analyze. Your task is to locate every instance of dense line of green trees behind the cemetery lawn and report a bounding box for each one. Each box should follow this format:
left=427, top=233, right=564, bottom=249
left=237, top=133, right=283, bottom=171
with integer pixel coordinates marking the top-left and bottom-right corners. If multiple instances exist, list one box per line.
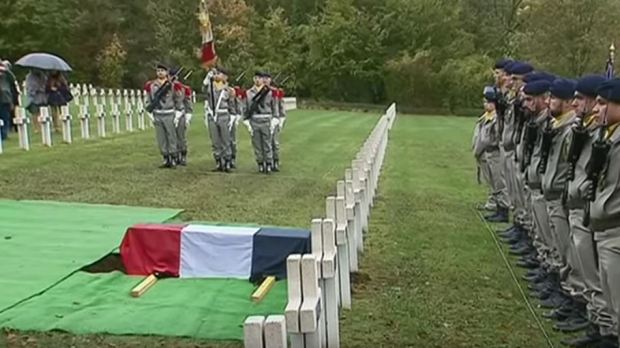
left=0, top=0, right=620, bottom=110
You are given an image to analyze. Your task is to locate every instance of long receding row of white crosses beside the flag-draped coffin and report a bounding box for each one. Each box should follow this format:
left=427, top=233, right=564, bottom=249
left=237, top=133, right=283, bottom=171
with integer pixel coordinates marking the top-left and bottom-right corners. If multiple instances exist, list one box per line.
left=244, top=104, right=396, bottom=348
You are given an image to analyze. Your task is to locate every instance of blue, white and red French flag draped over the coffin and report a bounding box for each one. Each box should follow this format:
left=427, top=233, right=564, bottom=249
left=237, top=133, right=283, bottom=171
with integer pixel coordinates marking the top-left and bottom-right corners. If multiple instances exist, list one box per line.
left=120, top=224, right=311, bottom=281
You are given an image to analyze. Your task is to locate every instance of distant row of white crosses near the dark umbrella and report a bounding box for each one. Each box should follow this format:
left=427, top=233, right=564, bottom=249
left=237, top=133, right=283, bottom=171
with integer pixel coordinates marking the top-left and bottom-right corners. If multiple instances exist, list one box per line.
left=0, top=84, right=152, bottom=153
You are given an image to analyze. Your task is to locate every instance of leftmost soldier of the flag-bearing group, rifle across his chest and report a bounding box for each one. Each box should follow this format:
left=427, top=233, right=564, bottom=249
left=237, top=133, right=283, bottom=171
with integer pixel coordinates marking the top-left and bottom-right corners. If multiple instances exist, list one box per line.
left=145, top=64, right=184, bottom=168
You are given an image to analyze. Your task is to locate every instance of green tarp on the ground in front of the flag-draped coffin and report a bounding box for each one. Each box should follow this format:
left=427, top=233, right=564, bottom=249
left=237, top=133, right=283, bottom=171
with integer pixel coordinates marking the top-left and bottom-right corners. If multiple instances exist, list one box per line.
left=0, top=272, right=286, bottom=340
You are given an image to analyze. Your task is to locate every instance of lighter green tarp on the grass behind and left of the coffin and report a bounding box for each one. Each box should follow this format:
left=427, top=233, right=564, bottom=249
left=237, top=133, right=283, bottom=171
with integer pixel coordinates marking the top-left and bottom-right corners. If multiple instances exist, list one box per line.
left=0, top=200, right=181, bottom=313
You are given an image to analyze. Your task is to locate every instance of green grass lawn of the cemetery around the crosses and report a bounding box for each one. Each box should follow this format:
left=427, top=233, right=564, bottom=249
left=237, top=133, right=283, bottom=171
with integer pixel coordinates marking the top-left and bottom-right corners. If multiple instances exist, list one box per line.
left=0, top=111, right=561, bottom=348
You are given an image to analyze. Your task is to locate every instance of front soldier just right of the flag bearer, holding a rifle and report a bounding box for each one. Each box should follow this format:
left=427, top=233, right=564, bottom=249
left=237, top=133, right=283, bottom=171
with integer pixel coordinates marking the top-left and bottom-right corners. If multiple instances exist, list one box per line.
left=245, top=72, right=278, bottom=174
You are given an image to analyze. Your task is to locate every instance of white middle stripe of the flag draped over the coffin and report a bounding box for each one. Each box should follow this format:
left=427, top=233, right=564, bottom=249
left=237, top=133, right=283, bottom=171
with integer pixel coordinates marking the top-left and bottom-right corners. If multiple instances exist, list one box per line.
left=180, top=225, right=260, bottom=279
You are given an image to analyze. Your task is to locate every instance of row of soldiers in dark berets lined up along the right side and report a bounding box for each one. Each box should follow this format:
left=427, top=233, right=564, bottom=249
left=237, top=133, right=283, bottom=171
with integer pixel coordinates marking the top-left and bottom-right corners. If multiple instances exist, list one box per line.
left=474, top=60, right=620, bottom=348
